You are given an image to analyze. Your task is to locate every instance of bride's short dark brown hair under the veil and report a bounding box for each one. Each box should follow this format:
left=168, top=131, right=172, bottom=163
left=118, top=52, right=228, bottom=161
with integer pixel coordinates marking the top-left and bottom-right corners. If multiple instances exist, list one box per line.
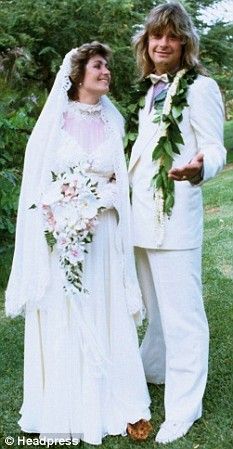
left=67, top=41, right=112, bottom=100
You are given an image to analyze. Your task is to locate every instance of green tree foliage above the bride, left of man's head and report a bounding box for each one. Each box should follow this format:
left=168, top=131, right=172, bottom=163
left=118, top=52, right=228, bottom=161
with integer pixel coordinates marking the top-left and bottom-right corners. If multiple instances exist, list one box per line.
left=0, top=0, right=147, bottom=99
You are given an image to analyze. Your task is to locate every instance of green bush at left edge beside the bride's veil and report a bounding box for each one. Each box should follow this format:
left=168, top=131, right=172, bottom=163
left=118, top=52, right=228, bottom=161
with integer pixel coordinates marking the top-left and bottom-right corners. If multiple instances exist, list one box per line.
left=0, top=78, right=44, bottom=288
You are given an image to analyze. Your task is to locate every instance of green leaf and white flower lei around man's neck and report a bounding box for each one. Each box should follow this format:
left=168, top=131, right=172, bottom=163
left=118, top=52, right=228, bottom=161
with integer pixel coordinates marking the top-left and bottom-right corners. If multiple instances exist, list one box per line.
left=125, top=68, right=197, bottom=244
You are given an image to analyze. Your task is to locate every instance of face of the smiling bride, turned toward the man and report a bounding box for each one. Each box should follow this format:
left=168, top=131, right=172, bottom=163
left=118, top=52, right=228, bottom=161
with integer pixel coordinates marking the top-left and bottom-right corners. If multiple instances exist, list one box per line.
left=80, top=55, right=111, bottom=97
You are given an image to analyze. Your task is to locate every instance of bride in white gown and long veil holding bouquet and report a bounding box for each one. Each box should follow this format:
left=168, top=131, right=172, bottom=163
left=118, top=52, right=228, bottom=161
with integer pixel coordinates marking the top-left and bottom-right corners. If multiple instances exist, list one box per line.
left=6, top=42, right=150, bottom=445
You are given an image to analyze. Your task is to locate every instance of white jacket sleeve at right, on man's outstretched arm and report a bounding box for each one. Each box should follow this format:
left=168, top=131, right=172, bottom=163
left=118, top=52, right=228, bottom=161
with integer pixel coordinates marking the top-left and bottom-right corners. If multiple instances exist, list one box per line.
left=188, top=76, right=226, bottom=182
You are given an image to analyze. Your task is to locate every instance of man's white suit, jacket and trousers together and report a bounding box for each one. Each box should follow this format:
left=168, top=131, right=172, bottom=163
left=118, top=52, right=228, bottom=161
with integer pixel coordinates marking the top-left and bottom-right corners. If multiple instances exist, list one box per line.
left=129, top=75, right=226, bottom=422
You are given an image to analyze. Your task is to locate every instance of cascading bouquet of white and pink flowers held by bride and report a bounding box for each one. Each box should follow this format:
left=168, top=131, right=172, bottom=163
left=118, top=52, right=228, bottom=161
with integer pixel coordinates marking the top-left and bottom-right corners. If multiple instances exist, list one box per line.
left=42, top=161, right=104, bottom=294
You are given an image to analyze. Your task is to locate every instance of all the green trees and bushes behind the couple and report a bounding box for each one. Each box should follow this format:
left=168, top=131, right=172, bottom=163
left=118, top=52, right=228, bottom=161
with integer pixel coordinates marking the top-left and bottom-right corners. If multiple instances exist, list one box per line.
left=0, top=0, right=233, bottom=286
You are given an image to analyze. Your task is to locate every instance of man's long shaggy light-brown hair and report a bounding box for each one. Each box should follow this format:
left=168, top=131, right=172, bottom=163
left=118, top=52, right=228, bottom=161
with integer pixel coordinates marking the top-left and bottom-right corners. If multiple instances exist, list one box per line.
left=133, top=2, right=207, bottom=77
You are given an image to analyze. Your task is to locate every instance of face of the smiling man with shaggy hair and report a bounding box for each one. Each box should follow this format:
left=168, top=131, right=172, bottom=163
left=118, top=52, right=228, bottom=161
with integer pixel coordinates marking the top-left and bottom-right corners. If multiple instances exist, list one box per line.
left=148, top=29, right=184, bottom=74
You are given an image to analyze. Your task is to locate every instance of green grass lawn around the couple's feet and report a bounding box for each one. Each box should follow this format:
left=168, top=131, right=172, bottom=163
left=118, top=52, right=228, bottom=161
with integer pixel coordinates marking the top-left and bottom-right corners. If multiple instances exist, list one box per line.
left=0, top=166, right=233, bottom=449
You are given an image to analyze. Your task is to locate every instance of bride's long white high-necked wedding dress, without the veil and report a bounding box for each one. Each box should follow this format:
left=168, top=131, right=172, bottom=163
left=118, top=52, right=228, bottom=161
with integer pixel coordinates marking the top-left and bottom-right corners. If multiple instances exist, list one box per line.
left=19, top=102, right=150, bottom=445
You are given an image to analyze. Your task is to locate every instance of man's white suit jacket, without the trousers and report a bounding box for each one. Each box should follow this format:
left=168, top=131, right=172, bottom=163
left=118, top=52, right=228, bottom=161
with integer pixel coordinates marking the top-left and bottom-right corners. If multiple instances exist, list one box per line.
left=129, top=75, right=226, bottom=250
